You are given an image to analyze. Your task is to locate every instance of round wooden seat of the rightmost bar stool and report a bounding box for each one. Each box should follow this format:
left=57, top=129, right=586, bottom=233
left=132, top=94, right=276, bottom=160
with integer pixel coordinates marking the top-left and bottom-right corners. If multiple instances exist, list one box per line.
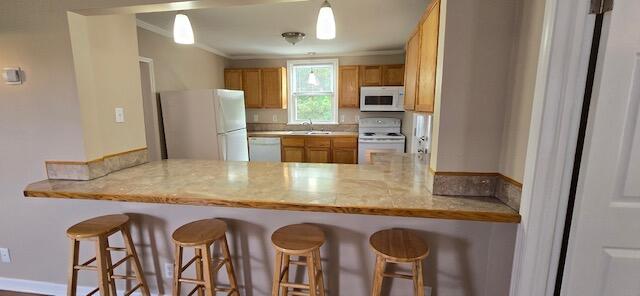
left=369, top=229, right=429, bottom=262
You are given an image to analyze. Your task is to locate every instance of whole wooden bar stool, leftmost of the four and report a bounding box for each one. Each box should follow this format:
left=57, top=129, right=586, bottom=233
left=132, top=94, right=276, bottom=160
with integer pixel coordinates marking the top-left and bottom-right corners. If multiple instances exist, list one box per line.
left=67, top=215, right=149, bottom=296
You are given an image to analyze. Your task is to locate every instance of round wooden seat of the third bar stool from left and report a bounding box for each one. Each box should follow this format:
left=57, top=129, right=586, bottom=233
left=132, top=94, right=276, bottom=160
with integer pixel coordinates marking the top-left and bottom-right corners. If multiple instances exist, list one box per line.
left=271, top=224, right=325, bottom=254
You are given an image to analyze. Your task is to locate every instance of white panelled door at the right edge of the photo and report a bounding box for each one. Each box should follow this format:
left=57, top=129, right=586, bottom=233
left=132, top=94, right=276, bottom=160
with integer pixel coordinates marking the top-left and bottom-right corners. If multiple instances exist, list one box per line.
left=562, top=0, right=640, bottom=296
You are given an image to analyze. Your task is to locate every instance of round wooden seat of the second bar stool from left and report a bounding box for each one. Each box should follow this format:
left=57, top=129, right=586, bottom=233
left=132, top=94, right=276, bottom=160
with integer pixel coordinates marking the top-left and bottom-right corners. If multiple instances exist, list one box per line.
left=171, top=219, right=227, bottom=247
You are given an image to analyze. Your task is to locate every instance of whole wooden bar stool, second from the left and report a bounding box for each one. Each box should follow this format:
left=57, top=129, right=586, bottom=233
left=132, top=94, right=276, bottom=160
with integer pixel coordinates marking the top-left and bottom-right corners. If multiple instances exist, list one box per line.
left=172, top=219, right=240, bottom=296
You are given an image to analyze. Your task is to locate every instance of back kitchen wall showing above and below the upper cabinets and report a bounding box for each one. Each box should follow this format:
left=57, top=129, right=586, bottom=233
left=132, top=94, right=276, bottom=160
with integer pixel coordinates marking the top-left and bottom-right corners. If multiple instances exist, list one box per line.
left=228, top=54, right=404, bottom=124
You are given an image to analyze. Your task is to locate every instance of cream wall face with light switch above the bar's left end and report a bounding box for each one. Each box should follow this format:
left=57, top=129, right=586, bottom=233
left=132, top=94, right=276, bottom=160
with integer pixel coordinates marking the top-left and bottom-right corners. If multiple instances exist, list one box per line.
left=68, top=13, right=146, bottom=160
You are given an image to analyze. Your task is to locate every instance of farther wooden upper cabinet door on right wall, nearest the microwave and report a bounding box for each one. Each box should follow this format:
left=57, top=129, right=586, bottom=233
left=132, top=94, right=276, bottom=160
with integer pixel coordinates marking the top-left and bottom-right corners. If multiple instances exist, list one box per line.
left=404, top=25, right=422, bottom=110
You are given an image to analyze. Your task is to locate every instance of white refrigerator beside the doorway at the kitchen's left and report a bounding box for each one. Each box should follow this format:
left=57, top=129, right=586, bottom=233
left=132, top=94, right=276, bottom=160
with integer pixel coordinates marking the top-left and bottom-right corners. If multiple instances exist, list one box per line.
left=160, top=89, right=249, bottom=161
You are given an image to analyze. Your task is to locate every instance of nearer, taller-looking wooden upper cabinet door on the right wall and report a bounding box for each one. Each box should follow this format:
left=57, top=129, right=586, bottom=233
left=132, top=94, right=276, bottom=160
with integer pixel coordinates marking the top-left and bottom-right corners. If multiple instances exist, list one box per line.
left=415, top=1, right=440, bottom=112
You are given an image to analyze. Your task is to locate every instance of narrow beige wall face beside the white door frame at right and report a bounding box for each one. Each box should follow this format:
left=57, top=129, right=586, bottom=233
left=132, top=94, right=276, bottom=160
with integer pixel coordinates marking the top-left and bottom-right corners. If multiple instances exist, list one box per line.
left=499, top=0, right=544, bottom=182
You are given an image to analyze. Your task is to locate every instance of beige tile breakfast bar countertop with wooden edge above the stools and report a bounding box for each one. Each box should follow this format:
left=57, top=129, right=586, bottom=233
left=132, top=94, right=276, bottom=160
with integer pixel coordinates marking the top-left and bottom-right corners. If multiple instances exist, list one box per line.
left=24, top=154, right=520, bottom=223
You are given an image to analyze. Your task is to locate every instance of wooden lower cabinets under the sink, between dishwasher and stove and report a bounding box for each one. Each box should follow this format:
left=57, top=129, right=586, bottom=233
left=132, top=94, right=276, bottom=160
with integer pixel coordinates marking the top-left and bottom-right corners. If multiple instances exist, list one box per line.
left=281, top=136, right=358, bottom=164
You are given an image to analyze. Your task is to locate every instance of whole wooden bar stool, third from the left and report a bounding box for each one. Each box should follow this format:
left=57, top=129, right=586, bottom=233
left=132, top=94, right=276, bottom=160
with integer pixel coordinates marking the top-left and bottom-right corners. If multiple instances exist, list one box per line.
left=271, top=224, right=325, bottom=296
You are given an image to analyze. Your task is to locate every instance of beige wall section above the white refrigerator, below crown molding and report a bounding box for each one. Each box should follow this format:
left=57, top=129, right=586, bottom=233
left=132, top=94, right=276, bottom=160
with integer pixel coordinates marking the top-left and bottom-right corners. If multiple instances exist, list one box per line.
left=138, top=28, right=226, bottom=92
